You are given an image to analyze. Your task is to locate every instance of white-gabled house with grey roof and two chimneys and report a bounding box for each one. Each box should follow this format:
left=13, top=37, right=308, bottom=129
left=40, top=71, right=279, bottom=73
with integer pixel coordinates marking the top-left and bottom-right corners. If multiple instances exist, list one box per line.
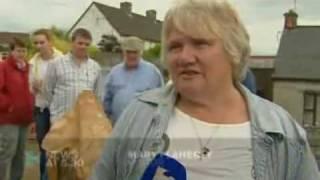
left=68, top=2, right=162, bottom=49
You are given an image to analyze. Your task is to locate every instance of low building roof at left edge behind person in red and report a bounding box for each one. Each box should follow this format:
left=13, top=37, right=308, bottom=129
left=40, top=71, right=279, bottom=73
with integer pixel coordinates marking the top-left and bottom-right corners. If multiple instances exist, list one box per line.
left=0, top=32, right=29, bottom=59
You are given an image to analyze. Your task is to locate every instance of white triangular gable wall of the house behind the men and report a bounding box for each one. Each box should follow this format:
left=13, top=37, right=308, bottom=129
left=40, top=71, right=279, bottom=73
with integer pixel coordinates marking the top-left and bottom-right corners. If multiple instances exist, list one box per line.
left=72, top=5, right=120, bottom=45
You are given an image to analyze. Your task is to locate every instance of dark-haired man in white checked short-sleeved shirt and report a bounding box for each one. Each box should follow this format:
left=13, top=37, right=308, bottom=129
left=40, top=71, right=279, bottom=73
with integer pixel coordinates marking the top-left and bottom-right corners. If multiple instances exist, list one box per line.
left=45, top=28, right=100, bottom=123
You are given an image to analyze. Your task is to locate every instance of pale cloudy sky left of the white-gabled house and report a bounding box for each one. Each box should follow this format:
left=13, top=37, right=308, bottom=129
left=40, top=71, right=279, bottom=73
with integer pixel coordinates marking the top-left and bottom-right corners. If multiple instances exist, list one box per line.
left=0, top=0, right=90, bottom=32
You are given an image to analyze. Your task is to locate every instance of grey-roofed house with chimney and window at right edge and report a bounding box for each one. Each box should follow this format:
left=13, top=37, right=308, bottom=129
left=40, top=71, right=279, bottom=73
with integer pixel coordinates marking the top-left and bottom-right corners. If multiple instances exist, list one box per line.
left=273, top=10, right=320, bottom=160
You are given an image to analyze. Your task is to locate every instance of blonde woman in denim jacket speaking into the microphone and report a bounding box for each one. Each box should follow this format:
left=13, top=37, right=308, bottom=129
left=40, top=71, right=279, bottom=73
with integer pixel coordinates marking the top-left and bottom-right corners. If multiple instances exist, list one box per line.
left=93, top=0, right=319, bottom=180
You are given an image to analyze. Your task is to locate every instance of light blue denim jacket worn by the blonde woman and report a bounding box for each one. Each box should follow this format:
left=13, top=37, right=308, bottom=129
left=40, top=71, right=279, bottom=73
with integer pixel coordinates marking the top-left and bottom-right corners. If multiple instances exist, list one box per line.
left=91, top=85, right=320, bottom=180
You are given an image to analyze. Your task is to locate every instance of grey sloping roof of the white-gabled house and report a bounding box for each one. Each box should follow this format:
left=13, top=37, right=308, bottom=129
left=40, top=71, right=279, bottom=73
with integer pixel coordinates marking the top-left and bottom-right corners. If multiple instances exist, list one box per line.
left=71, top=2, right=162, bottom=42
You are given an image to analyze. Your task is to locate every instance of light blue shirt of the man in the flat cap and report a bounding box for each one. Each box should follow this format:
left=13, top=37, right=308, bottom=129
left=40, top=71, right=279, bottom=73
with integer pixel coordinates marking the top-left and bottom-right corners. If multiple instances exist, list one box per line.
left=103, top=60, right=163, bottom=124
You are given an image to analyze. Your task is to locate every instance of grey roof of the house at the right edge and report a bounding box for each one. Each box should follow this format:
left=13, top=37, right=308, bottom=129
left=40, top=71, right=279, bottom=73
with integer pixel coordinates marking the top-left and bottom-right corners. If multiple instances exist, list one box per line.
left=273, top=26, right=320, bottom=80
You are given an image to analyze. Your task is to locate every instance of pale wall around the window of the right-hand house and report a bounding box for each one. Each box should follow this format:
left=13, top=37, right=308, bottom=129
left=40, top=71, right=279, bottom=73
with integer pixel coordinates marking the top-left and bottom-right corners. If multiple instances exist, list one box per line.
left=273, top=81, right=320, bottom=123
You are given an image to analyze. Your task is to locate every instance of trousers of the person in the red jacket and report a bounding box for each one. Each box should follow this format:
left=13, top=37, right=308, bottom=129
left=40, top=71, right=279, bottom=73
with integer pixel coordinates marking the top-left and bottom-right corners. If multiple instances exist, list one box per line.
left=0, top=125, right=28, bottom=180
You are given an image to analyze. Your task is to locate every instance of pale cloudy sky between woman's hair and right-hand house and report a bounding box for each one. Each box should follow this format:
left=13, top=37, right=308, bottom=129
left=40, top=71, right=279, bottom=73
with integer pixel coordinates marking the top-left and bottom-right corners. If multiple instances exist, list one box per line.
left=232, top=0, right=320, bottom=55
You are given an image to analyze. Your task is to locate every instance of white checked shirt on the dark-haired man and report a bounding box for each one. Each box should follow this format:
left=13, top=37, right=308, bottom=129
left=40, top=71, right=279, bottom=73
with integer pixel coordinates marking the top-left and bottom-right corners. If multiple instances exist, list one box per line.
left=44, top=53, right=101, bottom=123
